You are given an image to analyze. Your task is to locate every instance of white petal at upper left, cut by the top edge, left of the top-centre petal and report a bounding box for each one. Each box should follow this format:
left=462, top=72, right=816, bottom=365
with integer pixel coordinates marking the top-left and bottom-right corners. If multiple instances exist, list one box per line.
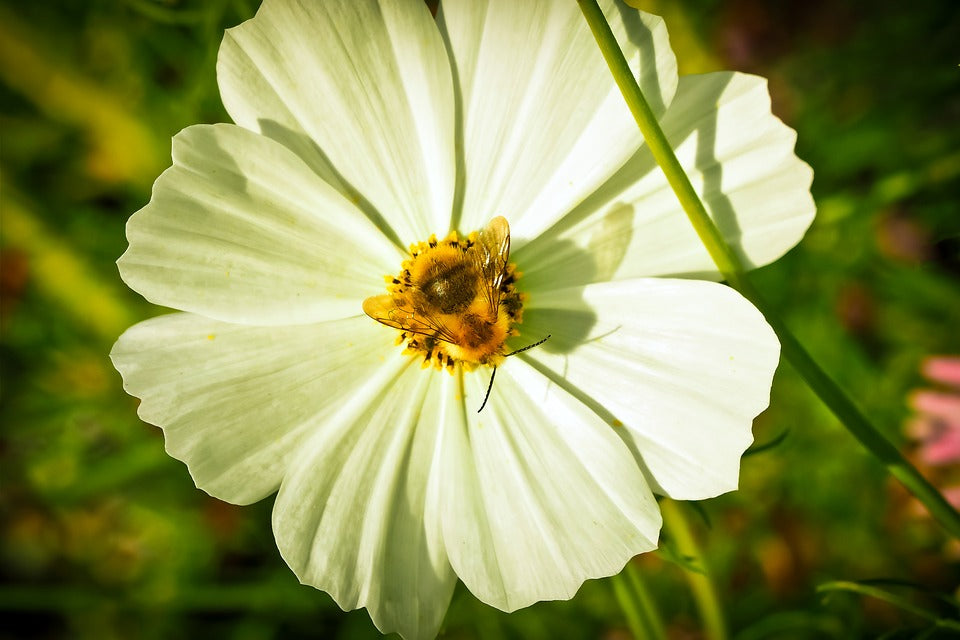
left=217, top=0, right=455, bottom=243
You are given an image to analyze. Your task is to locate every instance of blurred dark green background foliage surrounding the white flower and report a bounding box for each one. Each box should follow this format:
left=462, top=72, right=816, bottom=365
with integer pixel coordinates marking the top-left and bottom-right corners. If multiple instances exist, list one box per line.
left=0, top=0, right=960, bottom=640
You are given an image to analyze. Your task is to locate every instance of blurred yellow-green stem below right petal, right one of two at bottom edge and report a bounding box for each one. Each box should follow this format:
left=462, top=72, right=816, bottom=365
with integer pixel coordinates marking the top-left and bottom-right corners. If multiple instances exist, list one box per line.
left=660, top=498, right=727, bottom=640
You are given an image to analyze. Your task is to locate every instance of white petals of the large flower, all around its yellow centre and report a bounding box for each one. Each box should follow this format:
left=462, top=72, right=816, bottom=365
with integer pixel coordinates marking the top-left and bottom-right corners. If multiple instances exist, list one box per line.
left=111, top=0, right=814, bottom=638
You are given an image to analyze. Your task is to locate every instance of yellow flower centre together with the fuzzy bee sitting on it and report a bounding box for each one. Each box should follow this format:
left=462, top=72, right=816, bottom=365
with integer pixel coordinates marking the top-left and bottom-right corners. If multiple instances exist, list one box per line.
left=363, top=217, right=525, bottom=373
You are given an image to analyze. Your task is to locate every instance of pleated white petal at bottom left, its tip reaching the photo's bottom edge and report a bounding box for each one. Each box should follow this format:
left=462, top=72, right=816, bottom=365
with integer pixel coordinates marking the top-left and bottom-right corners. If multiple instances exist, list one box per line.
left=273, top=360, right=456, bottom=639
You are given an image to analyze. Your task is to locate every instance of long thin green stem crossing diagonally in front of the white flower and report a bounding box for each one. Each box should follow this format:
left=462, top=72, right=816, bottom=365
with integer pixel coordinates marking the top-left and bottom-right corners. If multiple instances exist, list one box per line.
left=577, top=0, right=960, bottom=538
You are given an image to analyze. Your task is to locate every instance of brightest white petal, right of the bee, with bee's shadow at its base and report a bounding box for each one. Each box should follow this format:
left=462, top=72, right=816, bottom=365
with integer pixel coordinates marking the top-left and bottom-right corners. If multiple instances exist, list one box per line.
left=519, top=279, right=780, bottom=500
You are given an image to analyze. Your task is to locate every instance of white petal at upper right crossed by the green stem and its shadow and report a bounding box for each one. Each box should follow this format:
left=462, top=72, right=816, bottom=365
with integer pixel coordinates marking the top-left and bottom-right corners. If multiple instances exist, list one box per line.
left=514, top=72, right=815, bottom=287
